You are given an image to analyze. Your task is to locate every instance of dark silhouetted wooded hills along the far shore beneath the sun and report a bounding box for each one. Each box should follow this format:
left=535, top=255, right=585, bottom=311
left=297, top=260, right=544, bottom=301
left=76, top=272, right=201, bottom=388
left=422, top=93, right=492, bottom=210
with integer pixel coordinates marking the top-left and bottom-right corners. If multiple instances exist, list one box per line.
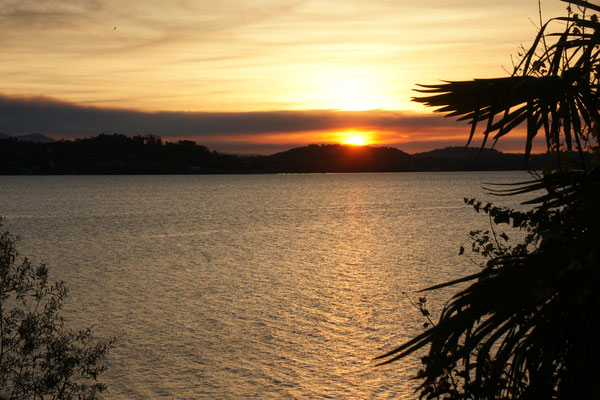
left=0, top=134, right=580, bottom=174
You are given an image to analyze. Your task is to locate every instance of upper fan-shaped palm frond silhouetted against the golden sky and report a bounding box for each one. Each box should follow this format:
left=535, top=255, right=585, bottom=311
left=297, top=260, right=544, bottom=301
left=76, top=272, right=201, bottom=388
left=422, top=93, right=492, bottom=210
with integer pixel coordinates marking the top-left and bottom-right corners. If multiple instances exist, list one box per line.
left=413, top=11, right=600, bottom=158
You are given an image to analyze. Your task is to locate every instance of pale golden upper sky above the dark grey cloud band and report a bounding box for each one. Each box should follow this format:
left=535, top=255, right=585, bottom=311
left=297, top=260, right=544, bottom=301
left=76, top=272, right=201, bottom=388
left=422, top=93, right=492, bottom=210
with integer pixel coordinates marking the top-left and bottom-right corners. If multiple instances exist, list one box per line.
left=0, top=0, right=566, bottom=153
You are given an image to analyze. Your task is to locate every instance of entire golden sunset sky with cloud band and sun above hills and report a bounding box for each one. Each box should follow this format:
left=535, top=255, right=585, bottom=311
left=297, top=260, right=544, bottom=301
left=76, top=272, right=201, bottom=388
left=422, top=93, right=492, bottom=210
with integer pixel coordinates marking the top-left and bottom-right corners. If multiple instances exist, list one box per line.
left=0, top=0, right=566, bottom=154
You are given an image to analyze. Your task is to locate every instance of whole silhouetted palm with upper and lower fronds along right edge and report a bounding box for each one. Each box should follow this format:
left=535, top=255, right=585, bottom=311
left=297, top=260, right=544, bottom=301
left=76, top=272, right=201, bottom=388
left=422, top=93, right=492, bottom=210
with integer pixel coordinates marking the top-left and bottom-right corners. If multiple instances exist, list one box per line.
left=379, top=1, right=600, bottom=399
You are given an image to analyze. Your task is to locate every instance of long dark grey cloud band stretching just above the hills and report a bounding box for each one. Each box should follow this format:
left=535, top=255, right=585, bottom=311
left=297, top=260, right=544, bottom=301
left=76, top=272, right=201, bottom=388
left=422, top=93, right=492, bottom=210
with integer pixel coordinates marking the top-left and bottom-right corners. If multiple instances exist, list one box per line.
left=0, top=95, right=456, bottom=138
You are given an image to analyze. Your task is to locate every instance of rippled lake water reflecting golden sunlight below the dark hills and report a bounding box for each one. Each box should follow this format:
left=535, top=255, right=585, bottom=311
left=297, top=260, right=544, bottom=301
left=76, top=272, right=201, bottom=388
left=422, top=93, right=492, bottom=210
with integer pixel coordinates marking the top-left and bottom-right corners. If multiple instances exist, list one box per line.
left=0, top=172, right=529, bottom=399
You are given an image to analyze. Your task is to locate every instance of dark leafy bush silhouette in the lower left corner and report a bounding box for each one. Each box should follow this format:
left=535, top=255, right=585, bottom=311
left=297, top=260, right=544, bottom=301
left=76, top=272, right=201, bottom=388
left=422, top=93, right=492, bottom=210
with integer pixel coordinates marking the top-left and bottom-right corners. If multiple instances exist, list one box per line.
left=0, top=219, right=112, bottom=399
